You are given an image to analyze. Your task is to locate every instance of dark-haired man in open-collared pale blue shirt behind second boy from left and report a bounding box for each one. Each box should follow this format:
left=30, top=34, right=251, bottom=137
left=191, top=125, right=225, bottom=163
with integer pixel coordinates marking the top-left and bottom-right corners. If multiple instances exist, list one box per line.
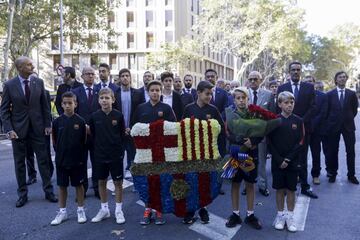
left=119, top=68, right=142, bottom=178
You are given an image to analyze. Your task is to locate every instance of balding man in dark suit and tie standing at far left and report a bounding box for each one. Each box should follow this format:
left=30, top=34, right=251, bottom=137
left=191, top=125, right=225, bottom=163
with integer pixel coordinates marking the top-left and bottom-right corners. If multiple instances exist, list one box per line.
left=0, top=57, right=57, bottom=207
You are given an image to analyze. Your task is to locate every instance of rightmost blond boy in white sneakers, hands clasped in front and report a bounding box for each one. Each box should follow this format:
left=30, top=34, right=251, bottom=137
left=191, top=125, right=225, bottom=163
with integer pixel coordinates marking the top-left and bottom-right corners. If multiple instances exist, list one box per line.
left=269, top=91, right=305, bottom=232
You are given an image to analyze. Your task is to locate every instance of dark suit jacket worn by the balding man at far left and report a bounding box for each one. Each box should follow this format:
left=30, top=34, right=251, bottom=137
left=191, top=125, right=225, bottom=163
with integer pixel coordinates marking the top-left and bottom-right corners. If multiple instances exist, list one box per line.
left=0, top=77, right=51, bottom=138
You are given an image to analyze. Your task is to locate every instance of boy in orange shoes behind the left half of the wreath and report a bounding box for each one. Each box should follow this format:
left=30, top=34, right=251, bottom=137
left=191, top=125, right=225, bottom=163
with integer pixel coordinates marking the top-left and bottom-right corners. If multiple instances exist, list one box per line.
left=131, top=80, right=176, bottom=225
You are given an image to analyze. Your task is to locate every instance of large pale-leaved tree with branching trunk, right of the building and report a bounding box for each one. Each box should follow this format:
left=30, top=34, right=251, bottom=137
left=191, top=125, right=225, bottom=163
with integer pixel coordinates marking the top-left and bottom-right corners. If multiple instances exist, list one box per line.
left=194, top=0, right=311, bottom=83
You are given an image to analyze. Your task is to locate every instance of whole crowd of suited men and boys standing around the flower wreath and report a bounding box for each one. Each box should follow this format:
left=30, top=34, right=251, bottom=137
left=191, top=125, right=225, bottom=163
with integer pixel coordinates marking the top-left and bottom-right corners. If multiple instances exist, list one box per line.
left=0, top=57, right=359, bottom=232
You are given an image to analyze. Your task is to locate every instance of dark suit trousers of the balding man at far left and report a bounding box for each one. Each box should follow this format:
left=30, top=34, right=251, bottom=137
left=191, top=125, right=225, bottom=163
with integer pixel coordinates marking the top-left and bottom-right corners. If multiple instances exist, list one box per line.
left=12, top=127, right=53, bottom=197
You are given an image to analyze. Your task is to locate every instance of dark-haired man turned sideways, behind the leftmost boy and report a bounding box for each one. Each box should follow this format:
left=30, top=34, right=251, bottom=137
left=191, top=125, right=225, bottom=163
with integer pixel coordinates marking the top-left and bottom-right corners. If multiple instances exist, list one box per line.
left=55, top=67, right=82, bottom=115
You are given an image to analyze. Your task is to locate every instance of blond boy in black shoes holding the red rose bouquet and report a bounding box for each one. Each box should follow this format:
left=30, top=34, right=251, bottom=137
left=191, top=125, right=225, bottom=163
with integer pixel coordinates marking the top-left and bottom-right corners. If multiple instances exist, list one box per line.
left=225, top=87, right=262, bottom=229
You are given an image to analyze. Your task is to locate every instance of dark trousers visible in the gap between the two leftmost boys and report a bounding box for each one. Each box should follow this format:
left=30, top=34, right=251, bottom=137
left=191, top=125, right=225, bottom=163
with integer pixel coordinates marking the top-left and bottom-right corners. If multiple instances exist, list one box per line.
left=83, top=136, right=99, bottom=193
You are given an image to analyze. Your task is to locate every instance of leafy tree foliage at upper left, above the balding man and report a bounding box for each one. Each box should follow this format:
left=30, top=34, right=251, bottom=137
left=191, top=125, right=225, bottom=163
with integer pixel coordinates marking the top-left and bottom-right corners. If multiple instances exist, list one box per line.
left=0, top=0, right=120, bottom=78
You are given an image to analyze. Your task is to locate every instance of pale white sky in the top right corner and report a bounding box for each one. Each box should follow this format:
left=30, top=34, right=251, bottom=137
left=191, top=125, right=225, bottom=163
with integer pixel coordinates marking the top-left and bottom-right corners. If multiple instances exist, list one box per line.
left=297, top=0, right=360, bottom=36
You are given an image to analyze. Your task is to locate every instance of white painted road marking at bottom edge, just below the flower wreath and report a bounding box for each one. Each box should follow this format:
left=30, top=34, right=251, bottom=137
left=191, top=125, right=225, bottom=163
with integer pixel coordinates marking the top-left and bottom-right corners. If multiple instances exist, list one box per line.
left=189, top=213, right=241, bottom=240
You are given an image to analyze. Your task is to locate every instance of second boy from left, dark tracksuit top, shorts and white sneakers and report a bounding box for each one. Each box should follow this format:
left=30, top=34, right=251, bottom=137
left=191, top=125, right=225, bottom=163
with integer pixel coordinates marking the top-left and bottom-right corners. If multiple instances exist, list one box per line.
left=89, top=88, right=125, bottom=224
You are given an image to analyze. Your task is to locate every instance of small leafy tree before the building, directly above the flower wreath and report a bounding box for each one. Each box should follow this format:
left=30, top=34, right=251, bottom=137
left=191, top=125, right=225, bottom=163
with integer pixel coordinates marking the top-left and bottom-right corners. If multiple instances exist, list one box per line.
left=146, top=38, right=202, bottom=75
